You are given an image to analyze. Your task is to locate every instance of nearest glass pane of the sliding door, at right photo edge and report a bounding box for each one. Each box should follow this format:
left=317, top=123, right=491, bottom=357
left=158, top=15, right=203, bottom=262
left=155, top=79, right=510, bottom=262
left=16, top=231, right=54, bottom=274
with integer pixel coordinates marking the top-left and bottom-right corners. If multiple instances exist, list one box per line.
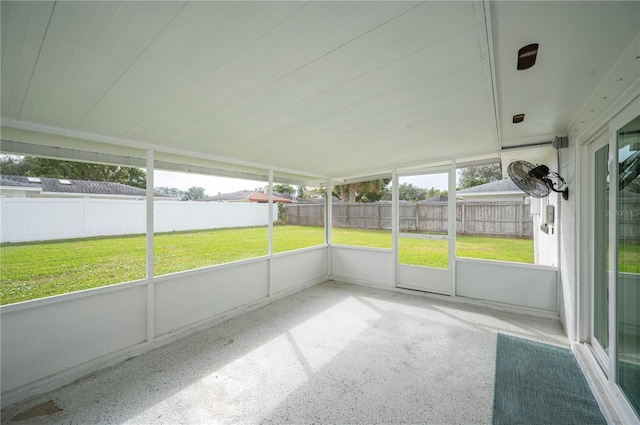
left=616, top=116, right=640, bottom=416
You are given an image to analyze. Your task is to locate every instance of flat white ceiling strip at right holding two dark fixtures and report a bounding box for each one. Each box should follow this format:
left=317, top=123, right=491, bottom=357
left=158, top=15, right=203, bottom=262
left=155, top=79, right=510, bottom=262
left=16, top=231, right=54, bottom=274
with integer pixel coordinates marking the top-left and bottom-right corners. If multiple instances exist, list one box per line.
left=491, top=1, right=640, bottom=147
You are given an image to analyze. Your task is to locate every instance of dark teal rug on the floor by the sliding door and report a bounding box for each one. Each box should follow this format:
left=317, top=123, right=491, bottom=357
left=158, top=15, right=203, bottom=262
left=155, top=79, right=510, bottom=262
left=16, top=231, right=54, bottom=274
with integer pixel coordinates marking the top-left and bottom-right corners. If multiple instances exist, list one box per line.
left=492, top=334, right=607, bottom=425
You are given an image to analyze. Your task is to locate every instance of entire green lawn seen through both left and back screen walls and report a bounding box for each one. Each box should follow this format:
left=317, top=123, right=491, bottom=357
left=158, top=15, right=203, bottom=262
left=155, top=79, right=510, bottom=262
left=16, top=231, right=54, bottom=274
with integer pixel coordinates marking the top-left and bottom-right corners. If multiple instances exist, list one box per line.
left=0, top=226, right=600, bottom=304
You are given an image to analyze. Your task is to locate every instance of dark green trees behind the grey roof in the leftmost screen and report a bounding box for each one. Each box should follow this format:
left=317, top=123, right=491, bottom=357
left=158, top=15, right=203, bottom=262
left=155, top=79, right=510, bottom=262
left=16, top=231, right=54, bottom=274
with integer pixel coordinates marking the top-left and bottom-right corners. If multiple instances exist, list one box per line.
left=0, top=155, right=147, bottom=188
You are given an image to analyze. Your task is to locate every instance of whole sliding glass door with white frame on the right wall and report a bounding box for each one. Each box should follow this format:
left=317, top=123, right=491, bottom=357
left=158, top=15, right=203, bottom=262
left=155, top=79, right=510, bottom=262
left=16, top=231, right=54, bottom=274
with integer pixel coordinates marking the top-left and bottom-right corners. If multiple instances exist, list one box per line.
left=588, top=107, right=640, bottom=421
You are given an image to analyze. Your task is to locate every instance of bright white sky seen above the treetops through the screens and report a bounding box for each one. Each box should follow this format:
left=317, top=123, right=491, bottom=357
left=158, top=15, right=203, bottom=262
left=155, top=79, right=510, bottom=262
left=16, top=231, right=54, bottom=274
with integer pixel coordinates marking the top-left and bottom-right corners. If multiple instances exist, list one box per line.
left=154, top=170, right=448, bottom=196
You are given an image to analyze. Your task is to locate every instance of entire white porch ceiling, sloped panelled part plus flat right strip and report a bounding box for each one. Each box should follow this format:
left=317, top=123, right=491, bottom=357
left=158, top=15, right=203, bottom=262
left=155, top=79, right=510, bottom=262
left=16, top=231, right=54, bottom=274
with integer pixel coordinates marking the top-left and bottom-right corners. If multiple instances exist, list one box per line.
left=1, top=1, right=640, bottom=179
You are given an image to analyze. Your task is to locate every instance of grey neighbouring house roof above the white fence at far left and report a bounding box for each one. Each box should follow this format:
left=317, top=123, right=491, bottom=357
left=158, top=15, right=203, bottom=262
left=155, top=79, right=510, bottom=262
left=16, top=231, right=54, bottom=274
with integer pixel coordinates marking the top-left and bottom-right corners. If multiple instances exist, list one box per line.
left=0, top=175, right=165, bottom=197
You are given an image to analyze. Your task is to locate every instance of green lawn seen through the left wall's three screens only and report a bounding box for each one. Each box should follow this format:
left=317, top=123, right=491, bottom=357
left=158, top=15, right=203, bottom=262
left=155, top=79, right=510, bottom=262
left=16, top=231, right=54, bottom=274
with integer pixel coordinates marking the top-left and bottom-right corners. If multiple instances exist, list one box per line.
left=0, top=226, right=324, bottom=304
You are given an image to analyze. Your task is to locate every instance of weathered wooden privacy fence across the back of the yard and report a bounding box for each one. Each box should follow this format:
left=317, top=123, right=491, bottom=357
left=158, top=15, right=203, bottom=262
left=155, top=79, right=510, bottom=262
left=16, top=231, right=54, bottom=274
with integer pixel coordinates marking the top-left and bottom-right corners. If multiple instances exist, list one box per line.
left=284, top=201, right=533, bottom=237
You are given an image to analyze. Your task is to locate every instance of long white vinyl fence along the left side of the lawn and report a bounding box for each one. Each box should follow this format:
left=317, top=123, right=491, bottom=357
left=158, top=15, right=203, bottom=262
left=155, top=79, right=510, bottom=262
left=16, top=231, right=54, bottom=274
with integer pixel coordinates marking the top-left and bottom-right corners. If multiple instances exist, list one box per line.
left=0, top=198, right=278, bottom=242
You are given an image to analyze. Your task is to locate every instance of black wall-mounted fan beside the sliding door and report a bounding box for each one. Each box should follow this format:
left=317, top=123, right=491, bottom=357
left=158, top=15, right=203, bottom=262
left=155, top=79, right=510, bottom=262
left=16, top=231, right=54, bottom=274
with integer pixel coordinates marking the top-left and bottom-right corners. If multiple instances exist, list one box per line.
left=507, top=161, right=569, bottom=201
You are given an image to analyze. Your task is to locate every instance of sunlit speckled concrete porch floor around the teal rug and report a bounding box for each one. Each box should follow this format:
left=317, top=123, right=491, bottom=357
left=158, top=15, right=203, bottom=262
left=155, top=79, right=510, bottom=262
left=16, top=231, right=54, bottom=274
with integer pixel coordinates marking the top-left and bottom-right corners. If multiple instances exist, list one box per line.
left=2, top=282, right=568, bottom=425
